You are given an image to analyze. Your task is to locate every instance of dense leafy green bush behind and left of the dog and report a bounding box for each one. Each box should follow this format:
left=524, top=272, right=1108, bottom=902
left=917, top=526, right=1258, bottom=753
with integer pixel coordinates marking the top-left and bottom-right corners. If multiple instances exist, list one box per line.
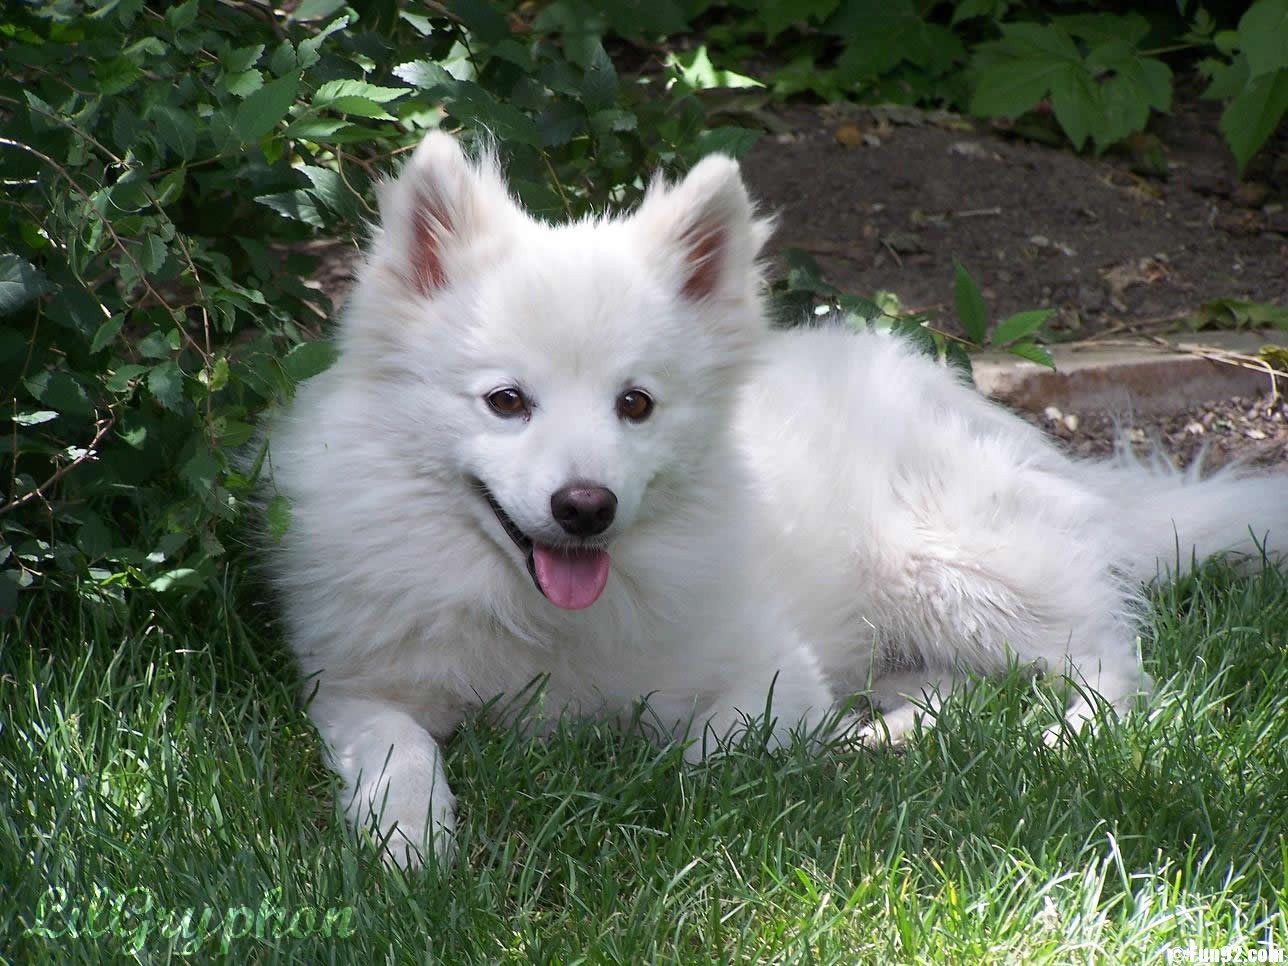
left=0, top=0, right=755, bottom=611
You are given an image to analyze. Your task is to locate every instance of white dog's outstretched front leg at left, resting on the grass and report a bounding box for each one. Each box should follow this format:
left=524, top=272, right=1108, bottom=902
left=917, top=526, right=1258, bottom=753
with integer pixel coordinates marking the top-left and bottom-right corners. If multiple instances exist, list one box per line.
left=309, top=687, right=456, bottom=867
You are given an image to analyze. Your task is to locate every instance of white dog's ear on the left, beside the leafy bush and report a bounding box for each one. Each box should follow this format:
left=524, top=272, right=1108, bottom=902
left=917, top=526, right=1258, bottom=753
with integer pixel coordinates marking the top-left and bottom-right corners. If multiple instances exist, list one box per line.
left=376, top=131, right=519, bottom=296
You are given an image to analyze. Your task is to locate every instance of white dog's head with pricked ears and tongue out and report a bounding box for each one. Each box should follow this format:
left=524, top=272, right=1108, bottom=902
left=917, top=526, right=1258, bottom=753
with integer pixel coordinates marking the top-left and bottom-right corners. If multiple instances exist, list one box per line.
left=341, top=133, right=768, bottom=609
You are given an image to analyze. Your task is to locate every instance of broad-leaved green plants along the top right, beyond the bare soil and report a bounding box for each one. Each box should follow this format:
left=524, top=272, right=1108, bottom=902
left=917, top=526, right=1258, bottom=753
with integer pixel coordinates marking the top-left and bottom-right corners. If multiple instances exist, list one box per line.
left=712, top=0, right=1288, bottom=170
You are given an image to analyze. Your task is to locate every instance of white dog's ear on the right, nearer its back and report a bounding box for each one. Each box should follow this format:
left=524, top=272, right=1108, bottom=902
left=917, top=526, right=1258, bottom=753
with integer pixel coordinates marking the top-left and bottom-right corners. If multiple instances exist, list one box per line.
left=635, top=155, right=770, bottom=301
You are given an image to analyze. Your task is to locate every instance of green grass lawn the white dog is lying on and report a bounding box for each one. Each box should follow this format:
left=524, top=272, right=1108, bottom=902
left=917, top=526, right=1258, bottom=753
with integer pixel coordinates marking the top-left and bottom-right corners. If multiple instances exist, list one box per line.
left=0, top=568, right=1288, bottom=963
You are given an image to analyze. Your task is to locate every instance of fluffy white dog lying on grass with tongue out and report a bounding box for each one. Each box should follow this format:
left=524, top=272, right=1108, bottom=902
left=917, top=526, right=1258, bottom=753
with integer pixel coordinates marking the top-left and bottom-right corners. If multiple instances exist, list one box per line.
left=270, top=134, right=1288, bottom=862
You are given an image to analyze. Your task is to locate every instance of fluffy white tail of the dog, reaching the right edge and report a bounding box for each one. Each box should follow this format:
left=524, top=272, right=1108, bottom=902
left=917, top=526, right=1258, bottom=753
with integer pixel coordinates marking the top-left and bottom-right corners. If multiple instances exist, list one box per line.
left=1083, top=453, right=1288, bottom=581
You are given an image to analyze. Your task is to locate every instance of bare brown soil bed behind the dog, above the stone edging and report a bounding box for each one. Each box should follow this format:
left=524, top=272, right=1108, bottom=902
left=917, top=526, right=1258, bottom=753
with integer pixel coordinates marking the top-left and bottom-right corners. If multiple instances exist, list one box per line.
left=744, top=94, right=1288, bottom=337
